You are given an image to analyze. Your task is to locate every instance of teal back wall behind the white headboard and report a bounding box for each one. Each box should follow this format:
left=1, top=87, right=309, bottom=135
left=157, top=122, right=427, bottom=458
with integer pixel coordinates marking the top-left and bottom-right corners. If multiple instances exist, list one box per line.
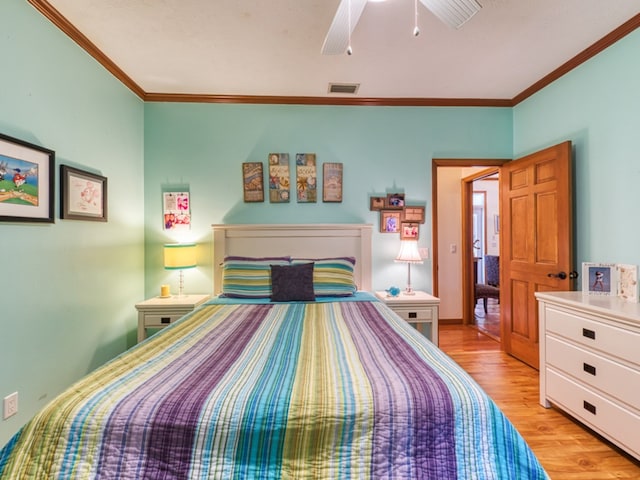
left=145, top=103, right=512, bottom=295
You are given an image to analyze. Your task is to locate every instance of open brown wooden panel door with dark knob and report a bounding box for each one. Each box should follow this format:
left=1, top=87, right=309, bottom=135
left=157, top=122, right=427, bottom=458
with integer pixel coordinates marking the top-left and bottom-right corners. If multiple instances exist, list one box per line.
left=500, top=141, right=574, bottom=368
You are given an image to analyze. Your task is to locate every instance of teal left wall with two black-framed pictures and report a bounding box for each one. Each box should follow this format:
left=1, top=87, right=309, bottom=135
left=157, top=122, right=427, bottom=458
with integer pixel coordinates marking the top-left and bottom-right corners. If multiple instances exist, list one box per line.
left=0, top=0, right=144, bottom=444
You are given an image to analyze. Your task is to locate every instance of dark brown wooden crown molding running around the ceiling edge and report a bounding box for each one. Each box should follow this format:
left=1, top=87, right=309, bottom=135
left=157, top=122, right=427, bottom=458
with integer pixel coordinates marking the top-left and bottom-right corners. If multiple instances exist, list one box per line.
left=27, top=0, right=640, bottom=107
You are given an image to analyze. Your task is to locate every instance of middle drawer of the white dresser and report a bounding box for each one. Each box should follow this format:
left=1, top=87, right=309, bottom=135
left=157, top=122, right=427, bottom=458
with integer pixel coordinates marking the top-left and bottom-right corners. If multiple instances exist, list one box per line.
left=546, top=336, right=640, bottom=408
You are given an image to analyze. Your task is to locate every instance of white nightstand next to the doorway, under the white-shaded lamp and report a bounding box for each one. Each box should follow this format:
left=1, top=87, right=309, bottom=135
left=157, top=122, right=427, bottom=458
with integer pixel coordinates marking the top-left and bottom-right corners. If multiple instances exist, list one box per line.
left=376, top=290, right=440, bottom=345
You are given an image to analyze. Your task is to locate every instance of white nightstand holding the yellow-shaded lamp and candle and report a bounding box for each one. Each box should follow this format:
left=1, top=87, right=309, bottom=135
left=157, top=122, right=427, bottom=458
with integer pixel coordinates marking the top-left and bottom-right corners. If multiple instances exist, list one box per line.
left=136, top=295, right=209, bottom=342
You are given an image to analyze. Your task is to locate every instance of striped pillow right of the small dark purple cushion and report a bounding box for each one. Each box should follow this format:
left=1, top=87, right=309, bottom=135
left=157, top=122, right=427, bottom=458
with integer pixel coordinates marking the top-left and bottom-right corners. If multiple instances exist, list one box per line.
left=291, top=257, right=358, bottom=297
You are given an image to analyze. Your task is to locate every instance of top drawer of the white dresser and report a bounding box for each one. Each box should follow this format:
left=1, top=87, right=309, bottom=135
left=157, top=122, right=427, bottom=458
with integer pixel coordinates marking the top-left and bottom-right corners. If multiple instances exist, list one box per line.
left=546, top=307, right=640, bottom=366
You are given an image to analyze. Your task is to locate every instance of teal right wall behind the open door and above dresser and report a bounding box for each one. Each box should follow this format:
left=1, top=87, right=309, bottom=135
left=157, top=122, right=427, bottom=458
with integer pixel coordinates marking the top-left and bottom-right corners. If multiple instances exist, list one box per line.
left=513, top=30, right=640, bottom=266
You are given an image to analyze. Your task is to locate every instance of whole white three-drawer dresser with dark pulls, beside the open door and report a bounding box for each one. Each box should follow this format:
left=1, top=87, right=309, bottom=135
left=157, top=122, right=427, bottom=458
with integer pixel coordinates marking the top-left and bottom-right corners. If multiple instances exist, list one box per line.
left=536, top=292, right=640, bottom=459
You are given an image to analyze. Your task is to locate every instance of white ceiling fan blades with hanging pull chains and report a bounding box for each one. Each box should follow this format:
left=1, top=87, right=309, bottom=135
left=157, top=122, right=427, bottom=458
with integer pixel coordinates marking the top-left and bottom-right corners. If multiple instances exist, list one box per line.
left=322, top=0, right=482, bottom=55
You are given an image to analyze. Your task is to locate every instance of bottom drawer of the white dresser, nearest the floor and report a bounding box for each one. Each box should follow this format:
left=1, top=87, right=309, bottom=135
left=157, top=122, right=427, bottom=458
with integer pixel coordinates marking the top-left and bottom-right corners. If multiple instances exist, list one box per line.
left=547, top=369, right=640, bottom=459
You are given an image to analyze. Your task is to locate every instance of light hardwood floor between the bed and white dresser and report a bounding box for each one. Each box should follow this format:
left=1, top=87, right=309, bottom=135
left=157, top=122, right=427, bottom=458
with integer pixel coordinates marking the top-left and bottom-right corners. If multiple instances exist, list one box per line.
left=439, top=325, right=640, bottom=480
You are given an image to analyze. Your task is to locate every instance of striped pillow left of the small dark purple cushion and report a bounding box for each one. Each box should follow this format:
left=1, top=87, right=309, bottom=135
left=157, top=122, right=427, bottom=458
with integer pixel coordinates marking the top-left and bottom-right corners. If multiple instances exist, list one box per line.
left=222, top=256, right=291, bottom=298
